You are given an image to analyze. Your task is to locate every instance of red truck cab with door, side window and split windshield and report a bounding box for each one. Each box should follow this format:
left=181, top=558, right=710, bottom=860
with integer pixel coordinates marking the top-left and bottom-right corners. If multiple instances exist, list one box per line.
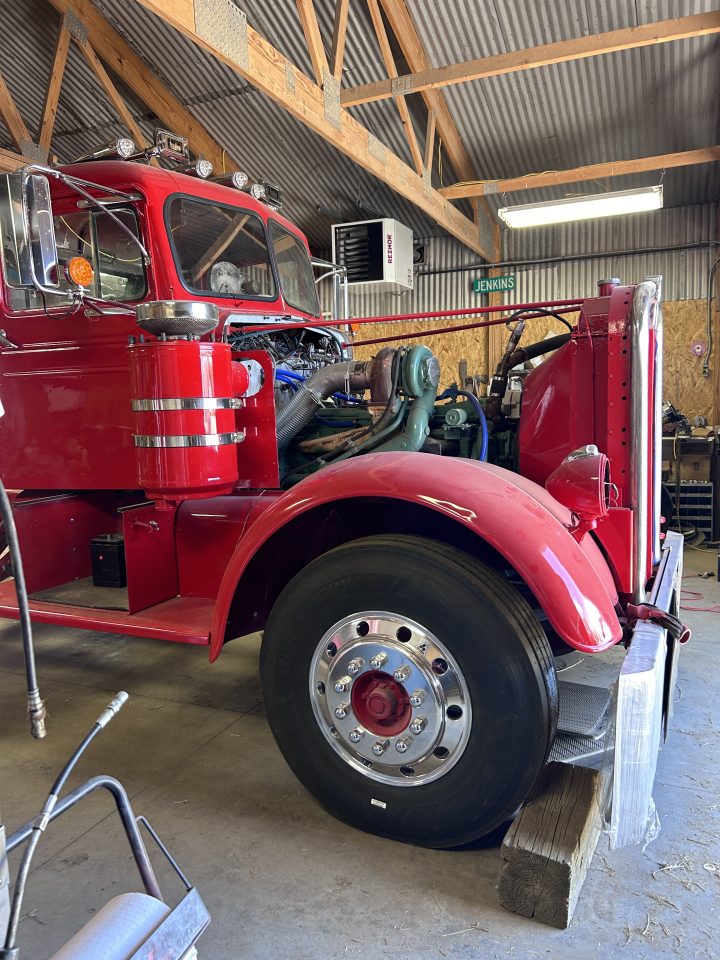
left=0, top=161, right=319, bottom=490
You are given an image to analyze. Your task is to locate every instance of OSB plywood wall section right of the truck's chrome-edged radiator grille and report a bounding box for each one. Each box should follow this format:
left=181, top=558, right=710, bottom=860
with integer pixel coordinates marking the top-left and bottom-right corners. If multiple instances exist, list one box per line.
left=663, top=300, right=720, bottom=423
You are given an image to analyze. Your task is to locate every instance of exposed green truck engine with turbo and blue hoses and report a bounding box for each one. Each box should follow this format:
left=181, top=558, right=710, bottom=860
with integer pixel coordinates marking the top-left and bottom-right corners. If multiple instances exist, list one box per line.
left=228, top=318, right=570, bottom=486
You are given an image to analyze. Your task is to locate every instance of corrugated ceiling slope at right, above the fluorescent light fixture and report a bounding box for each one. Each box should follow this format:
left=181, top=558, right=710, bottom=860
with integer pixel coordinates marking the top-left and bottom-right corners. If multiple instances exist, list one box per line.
left=408, top=0, right=720, bottom=207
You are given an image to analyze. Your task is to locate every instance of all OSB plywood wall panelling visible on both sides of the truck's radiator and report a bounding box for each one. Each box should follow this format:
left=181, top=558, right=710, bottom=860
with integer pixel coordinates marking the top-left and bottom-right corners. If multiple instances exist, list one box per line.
left=355, top=300, right=720, bottom=422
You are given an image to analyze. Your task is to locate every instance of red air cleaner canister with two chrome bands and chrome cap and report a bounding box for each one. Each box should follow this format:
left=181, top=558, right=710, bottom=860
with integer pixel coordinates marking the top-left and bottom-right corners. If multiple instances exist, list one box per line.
left=128, top=301, right=243, bottom=503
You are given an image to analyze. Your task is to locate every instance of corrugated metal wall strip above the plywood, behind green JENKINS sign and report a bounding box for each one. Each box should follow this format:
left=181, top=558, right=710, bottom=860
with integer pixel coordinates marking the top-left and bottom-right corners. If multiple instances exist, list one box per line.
left=323, top=203, right=720, bottom=317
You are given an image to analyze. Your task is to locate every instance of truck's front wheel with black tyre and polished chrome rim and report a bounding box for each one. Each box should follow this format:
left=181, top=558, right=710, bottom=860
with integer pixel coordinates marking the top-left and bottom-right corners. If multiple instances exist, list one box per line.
left=260, top=536, right=557, bottom=847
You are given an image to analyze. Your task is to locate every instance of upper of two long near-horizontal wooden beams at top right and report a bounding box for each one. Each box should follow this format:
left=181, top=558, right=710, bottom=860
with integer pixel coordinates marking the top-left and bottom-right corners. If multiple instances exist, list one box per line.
left=341, top=10, right=720, bottom=107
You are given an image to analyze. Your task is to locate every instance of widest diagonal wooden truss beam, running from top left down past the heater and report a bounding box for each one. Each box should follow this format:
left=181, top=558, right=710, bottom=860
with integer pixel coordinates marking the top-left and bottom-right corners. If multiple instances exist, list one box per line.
left=131, top=0, right=492, bottom=260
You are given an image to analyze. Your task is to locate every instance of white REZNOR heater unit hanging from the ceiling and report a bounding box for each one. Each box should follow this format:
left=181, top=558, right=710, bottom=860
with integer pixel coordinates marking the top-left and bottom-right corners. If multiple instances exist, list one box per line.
left=332, top=219, right=413, bottom=291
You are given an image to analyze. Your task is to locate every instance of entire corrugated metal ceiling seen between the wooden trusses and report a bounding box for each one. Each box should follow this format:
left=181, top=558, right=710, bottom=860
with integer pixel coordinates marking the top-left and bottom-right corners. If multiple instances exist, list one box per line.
left=0, top=0, right=720, bottom=255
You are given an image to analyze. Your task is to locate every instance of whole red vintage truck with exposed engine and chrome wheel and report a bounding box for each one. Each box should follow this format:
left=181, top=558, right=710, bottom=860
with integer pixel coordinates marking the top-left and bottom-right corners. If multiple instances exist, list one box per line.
left=0, top=135, right=685, bottom=847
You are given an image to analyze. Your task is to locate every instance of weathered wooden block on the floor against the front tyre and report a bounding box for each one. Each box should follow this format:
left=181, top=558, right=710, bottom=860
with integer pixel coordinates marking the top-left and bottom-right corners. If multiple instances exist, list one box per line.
left=498, top=763, right=601, bottom=930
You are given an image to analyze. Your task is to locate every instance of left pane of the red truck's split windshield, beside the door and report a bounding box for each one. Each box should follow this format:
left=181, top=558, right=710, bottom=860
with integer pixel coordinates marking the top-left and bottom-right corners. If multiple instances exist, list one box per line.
left=168, top=197, right=276, bottom=300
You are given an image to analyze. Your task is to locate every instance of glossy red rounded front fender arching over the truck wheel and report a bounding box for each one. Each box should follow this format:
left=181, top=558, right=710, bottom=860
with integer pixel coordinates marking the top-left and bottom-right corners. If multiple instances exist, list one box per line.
left=210, top=453, right=622, bottom=660
